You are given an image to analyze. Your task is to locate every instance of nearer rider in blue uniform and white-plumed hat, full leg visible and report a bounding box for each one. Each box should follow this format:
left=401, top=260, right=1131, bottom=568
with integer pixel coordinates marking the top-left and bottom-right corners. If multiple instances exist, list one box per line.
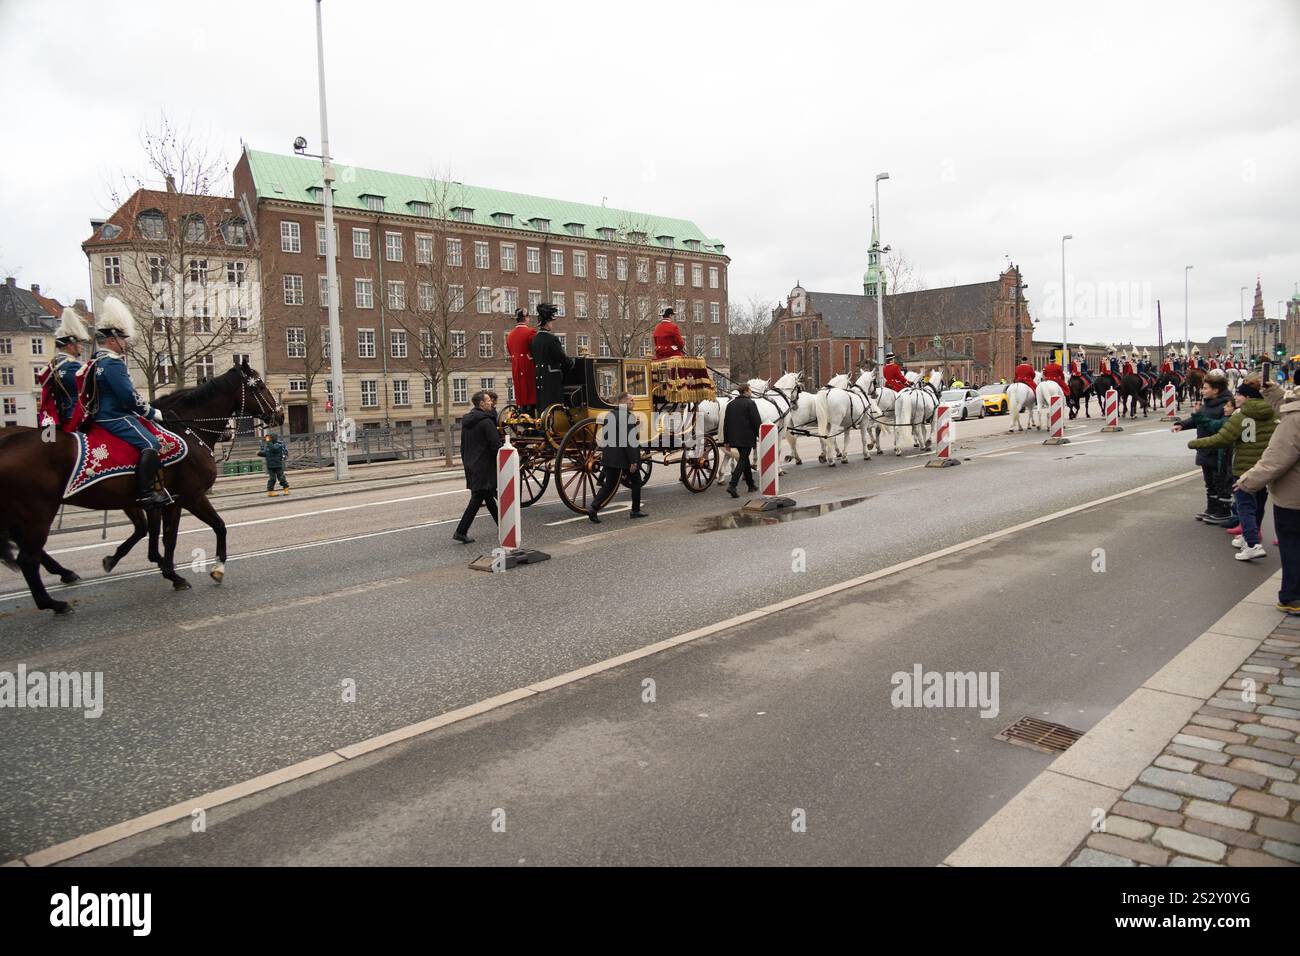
left=95, top=295, right=172, bottom=509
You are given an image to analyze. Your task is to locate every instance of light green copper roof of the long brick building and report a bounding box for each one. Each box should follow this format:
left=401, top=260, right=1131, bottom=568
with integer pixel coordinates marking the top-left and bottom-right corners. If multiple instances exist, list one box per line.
left=244, top=147, right=725, bottom=255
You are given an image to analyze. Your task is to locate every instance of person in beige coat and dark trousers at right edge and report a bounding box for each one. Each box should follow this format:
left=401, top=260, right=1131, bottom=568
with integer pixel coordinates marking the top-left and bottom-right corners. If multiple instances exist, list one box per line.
left=1235, top=382, right=1300, bottom=615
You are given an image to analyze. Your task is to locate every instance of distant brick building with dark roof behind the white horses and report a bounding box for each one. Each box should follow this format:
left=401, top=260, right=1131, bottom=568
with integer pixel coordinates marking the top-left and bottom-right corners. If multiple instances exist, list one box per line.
left=770, top=265, right=1032, bottom=384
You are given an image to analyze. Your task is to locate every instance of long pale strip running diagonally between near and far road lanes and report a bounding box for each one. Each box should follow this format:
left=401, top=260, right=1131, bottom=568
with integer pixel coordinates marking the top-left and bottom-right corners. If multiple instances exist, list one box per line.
left=22, top=468, right=1201, bottom=866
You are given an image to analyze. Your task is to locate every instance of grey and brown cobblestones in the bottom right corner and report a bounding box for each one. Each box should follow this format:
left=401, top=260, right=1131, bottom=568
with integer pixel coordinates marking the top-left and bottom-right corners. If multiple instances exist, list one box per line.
left=1069, top=618, right=1300, bottom=866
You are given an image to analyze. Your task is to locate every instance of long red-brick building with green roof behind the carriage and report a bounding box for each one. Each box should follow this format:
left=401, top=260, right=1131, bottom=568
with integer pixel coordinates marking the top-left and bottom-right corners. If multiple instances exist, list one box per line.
left=234, top=148, right=729, bottom=432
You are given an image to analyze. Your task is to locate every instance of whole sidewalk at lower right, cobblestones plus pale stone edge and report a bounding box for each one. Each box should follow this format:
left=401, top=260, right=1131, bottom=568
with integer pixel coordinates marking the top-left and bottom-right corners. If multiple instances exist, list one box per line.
left=945, top=571, right=1300, bottom=866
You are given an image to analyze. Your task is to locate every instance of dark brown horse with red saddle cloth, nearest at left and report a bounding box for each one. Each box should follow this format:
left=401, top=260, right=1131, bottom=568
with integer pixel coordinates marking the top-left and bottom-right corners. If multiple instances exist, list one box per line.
left=0, top=362, right=283, bottom=614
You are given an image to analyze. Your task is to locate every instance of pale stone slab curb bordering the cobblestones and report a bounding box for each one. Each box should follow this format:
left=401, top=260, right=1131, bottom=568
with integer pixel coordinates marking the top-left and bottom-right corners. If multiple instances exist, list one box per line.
left=944, top=571, right=1286, bottom=866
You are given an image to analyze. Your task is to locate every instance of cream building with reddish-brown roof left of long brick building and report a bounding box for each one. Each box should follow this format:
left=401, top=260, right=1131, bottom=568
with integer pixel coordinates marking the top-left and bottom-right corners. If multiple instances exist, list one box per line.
left=82, top=183, right=265, bottom=399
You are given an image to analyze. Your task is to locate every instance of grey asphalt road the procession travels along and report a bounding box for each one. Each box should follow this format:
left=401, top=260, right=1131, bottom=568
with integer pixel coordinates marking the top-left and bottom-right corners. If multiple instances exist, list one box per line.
left=0, top=408, right=1275, bottom=864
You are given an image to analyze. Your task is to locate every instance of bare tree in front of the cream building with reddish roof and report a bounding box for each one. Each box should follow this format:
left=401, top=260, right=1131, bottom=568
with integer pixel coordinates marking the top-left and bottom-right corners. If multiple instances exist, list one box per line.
left=111, top=116, right=246, bottom=401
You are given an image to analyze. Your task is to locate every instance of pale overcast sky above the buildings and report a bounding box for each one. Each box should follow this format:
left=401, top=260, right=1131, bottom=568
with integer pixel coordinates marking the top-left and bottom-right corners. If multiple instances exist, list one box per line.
left=0, top=0, right=1300, bottom=341
